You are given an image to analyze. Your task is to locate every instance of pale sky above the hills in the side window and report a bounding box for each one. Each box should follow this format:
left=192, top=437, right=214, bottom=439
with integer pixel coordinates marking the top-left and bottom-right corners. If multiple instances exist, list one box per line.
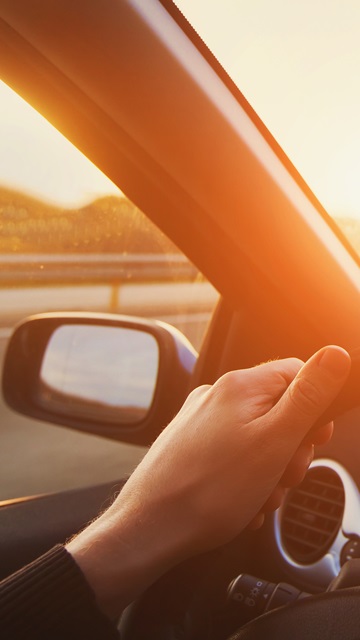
left=0, top=81, right=120, bottom=208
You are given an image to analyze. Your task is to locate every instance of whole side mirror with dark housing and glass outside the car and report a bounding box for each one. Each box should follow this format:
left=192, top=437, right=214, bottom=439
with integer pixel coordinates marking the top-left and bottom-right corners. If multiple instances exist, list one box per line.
left=3, top=313, right=197, bottom=445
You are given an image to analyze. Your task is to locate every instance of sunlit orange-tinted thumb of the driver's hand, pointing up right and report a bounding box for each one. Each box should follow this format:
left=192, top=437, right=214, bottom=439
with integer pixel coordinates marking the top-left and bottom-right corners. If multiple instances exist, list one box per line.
left=273, top=346, right=351, bottom=441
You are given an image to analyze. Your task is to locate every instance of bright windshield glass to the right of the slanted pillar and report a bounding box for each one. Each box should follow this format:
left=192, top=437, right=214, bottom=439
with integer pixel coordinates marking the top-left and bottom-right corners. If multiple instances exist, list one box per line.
left=176, top=0, right=360, bottom=253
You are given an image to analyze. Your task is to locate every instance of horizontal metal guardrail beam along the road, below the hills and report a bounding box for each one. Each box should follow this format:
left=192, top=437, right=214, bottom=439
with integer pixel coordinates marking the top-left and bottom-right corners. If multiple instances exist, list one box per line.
left=0, top=253, right=198, bottom=286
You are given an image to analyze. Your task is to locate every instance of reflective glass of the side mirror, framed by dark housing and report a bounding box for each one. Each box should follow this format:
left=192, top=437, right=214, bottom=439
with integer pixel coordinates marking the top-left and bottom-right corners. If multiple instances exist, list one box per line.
left=38, top=324, right=159, bottom=424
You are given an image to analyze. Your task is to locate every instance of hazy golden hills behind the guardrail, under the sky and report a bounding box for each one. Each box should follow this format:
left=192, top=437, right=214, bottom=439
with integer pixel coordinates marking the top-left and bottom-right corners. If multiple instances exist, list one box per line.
left=0, top=187, right=177, bottom=253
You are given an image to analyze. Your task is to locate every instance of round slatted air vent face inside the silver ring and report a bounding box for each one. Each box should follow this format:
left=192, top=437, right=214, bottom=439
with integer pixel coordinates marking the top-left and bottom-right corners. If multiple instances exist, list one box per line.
left=280, top=467, right=345, bottom=564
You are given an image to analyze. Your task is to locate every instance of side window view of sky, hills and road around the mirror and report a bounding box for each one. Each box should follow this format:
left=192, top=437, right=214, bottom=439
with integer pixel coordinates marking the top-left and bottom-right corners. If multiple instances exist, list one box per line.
left=0, top=83, right=218, bottom=501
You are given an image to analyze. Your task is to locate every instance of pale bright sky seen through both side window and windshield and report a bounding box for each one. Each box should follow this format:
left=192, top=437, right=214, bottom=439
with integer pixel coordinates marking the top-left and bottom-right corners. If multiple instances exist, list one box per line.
left=0, top=0, right=360, bottom=218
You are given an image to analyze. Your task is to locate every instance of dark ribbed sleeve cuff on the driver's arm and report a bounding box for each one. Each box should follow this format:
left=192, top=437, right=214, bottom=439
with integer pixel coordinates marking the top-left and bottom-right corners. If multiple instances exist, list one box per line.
left=0, top=545, right=119, bottom=640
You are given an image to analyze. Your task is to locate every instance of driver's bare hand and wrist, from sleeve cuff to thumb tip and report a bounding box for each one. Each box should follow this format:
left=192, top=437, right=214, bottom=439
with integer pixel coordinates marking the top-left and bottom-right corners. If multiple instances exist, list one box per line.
left=68, top=347, right=350, bottom=615
